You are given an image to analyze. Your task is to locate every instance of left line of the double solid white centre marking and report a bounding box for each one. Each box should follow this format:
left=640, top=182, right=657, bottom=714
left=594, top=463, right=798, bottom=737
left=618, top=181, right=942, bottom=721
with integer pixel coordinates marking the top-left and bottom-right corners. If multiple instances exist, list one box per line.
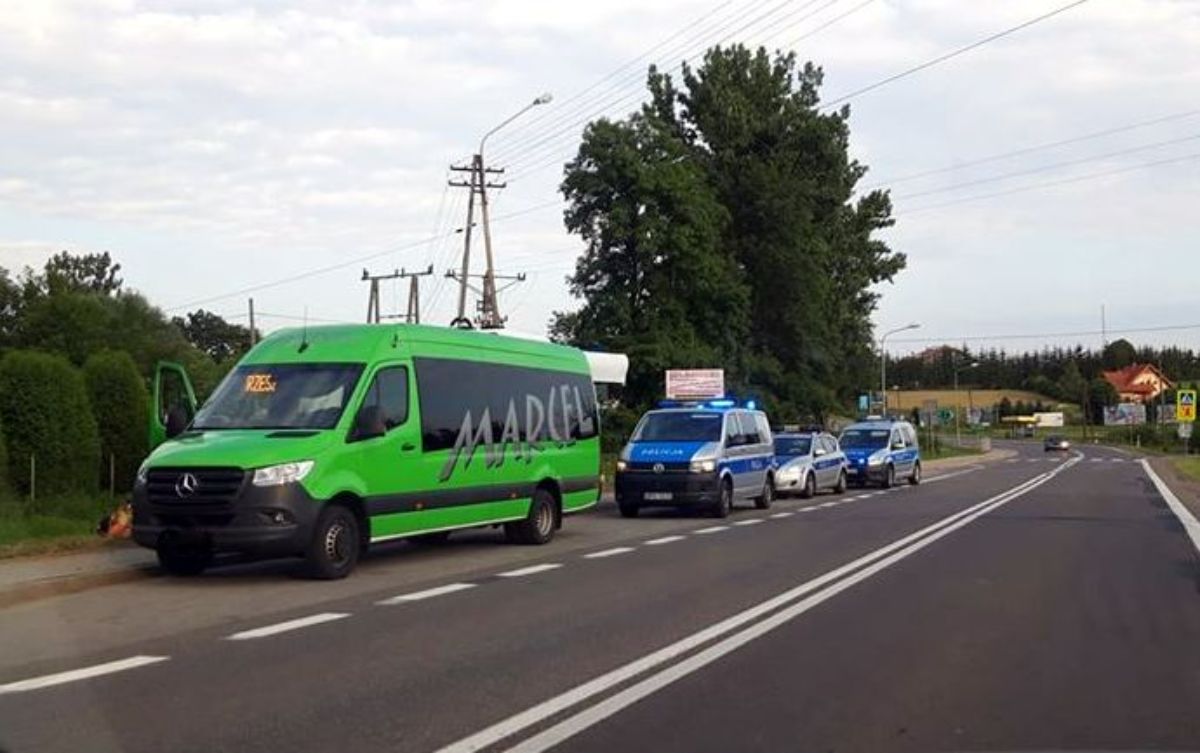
left=438, top=465, right=1067, bottom=753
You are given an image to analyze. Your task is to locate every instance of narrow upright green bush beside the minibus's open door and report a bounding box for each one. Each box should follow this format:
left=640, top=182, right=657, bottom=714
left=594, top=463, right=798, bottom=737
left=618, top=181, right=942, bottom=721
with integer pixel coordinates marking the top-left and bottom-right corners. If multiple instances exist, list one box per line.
left=83, top=350, right=150, bottom=492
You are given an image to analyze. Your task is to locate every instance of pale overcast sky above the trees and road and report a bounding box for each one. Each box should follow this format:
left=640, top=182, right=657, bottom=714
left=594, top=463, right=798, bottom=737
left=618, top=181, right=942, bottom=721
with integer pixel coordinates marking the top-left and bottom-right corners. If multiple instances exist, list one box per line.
left=0, top=0, right=1200, bottom=351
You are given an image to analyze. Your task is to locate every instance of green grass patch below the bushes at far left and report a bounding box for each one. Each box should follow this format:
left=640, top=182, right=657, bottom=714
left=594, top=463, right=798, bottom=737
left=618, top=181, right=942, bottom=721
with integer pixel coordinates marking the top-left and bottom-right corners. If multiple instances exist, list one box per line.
left=0, top=494, right=112, bottom=558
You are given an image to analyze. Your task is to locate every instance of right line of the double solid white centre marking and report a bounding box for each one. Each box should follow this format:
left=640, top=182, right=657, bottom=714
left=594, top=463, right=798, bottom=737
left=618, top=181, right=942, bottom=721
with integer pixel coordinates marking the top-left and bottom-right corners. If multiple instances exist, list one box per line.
left=508, top=453, right=1084, bottom=753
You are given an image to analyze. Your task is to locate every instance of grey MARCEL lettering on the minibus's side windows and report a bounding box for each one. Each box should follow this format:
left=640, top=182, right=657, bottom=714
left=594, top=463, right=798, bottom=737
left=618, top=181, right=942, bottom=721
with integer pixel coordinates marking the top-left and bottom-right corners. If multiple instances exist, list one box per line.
left=438, top=384, right=595, bottom=481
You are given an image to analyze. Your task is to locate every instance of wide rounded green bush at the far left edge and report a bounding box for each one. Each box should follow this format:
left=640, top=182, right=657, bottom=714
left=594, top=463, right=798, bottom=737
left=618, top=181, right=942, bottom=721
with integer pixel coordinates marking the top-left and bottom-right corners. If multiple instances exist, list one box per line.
left=0, top=350, right=100, bottom=503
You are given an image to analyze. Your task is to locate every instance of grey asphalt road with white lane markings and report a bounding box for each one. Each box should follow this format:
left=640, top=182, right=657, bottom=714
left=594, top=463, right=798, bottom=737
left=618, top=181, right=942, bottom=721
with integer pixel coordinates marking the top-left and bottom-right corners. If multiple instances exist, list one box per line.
left=0, top=446, right=1200, bottom=753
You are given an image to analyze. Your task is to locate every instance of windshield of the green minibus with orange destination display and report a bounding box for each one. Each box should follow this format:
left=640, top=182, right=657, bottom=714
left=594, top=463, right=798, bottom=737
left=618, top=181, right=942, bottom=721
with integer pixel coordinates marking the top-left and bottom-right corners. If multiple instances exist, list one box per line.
left=192, top=363, right=362, bottom=429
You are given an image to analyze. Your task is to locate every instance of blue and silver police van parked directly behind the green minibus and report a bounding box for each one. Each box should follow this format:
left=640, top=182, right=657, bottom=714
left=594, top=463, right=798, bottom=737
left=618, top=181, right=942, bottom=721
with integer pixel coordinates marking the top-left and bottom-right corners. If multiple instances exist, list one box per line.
left=616, top=399, right=775, bottom=518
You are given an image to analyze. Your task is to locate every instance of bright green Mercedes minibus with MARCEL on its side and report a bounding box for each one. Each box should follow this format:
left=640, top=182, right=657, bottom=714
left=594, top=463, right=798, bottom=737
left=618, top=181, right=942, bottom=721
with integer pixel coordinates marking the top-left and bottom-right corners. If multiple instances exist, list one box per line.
left=133, top=324, right=600, bottom=578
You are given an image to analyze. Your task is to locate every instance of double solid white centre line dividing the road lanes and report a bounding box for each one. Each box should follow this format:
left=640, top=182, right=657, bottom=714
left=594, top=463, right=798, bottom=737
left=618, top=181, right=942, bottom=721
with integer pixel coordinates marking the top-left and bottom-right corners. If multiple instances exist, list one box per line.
left=438, top=464, right=1069, bottom=753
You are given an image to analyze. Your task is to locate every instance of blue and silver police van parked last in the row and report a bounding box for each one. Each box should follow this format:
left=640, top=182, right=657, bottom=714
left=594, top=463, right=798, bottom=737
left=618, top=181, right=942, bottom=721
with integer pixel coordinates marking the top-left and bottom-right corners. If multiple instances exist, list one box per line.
left=839, top=420, right=920, bottom=488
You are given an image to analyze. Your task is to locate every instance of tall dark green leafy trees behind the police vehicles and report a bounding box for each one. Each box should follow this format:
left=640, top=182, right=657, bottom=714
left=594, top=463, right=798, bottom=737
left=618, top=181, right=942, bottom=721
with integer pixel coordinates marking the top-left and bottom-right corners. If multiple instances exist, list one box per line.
left=552, top=46, right=905, bottom=417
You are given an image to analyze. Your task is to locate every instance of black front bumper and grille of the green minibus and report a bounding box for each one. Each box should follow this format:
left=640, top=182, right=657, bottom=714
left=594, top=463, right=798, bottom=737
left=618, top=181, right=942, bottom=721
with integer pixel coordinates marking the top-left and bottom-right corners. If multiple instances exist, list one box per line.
left=133, top=469, right=320, bottom=556
